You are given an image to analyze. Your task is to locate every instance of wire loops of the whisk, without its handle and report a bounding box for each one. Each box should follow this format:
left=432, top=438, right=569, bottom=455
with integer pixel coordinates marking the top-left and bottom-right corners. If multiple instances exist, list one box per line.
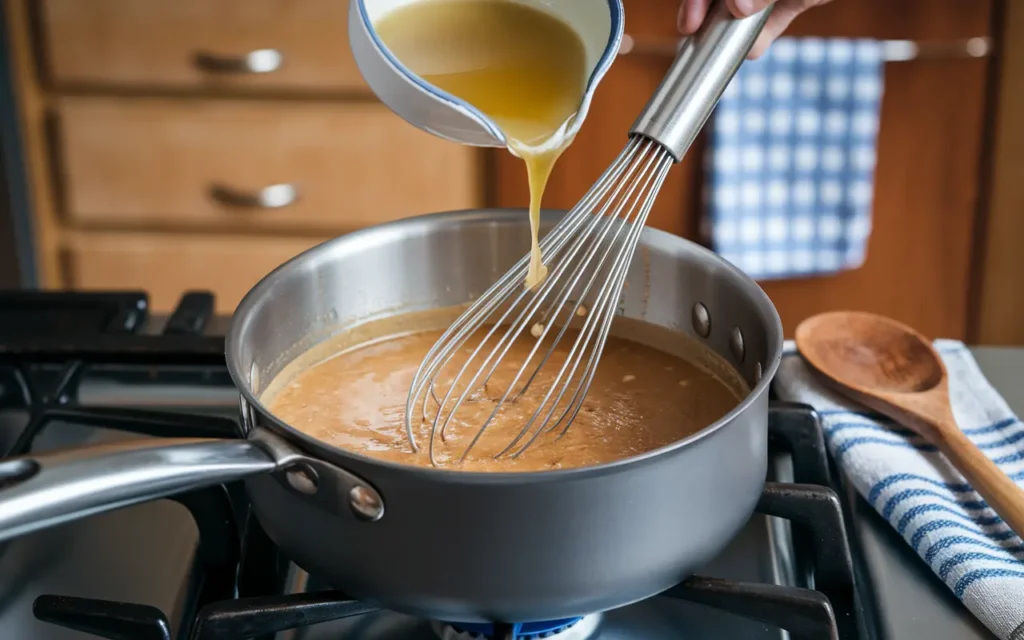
left=406, top=136, right=674, bottom=465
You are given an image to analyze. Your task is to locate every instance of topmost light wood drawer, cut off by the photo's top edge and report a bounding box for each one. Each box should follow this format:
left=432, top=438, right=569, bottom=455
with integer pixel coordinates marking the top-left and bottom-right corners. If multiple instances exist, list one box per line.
left=40, top=0, right=369, bottom=91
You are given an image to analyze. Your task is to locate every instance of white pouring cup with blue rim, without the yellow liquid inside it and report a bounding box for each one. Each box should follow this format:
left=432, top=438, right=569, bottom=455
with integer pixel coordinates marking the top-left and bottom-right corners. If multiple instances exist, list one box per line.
left=348, top=0, right=624, bottom=146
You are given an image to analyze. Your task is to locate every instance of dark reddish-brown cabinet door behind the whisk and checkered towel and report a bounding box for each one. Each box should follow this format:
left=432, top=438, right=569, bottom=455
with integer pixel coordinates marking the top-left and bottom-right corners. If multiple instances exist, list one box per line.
left=492, top=0, right=991, bottom=338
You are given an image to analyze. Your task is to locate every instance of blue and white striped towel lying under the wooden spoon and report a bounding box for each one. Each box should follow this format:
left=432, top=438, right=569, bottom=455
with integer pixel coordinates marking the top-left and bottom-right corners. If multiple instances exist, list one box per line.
left=775, top=340, right=1024, bottom=640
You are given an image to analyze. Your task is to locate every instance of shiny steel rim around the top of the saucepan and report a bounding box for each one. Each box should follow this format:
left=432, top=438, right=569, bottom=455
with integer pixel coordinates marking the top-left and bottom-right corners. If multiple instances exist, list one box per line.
left=224, top=208, right=783, bottom=484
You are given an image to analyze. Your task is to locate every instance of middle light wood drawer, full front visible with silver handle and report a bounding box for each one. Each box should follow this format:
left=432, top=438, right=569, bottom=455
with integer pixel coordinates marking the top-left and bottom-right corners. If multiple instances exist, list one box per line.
left=59, top=98, right=482, bottom=233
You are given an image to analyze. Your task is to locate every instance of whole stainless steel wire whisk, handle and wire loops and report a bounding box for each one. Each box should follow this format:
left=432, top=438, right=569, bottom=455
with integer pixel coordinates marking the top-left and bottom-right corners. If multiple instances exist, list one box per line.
left=406, top=2, right=770, bottom=466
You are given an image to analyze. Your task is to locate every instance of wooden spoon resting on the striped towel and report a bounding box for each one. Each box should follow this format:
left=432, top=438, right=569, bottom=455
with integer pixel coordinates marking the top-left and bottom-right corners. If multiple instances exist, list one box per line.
left=797, top=311, right=1024, bottom=538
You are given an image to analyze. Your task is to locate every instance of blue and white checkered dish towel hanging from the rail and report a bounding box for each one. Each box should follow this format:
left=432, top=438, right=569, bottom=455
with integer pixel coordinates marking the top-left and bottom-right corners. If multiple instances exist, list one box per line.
left=701, top=38, right=885, bottom=280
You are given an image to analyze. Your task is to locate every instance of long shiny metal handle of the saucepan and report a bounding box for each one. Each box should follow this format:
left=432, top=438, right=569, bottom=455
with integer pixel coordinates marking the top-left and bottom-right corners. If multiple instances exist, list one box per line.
left=0, top=438, right=284, bottom=542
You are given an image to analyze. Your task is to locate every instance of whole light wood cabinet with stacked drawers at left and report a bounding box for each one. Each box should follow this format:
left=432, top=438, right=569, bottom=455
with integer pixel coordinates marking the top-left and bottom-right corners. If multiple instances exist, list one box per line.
left=4, top=0, right=485, bottom=313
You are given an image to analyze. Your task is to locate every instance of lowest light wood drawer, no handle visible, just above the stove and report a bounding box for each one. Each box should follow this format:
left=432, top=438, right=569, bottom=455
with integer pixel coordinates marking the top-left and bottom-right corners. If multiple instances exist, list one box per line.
left=65, top=232, right=322, bottom=313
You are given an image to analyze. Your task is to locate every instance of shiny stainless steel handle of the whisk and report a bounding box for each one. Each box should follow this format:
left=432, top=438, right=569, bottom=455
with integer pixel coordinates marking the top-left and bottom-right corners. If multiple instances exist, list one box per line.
left=630, top=0, right=773, bottom=162
